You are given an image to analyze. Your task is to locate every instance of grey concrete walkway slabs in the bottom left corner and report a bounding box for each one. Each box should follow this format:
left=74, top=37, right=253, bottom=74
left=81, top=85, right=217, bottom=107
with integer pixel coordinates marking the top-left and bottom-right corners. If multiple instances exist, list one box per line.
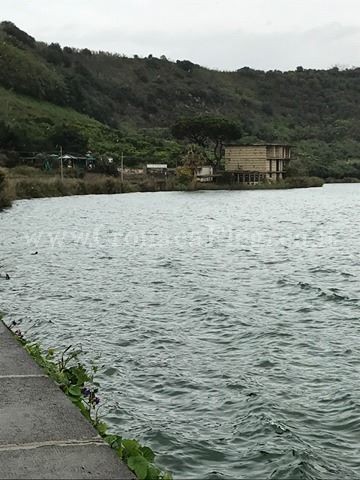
left=0, top=321, right=135, bottom=480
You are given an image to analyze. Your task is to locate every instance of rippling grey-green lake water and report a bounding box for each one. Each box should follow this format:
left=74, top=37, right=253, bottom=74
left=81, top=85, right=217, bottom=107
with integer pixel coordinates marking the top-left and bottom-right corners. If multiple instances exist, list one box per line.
left=0, top=184, right=360, bottom=479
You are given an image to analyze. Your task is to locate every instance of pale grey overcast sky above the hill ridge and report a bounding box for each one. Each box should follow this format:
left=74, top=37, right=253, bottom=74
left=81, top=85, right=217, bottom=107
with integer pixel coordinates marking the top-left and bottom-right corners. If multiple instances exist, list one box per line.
left=0, top=0, right=360, bottom=70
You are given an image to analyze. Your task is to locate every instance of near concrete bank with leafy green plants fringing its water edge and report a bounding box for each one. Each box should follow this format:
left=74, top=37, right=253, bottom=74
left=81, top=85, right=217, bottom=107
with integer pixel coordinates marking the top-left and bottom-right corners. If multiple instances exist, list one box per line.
left=0, top=316, right=172, bottom=480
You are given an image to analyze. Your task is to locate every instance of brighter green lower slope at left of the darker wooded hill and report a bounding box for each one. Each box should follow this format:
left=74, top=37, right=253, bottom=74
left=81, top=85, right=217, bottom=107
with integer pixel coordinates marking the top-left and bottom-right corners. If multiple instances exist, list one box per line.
left=0, top=87, right=182, bottom=165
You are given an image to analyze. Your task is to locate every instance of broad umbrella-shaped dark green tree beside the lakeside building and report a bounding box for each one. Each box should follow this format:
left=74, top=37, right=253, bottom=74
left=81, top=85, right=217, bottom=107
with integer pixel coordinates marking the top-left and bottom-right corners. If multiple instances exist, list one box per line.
left=172, top=115, right=242, bottom=168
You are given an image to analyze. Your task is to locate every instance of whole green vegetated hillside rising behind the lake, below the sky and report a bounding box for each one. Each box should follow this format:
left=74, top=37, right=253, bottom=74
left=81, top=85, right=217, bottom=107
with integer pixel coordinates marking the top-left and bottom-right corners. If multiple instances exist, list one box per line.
left=0, top=22, right=360, bottom=178
